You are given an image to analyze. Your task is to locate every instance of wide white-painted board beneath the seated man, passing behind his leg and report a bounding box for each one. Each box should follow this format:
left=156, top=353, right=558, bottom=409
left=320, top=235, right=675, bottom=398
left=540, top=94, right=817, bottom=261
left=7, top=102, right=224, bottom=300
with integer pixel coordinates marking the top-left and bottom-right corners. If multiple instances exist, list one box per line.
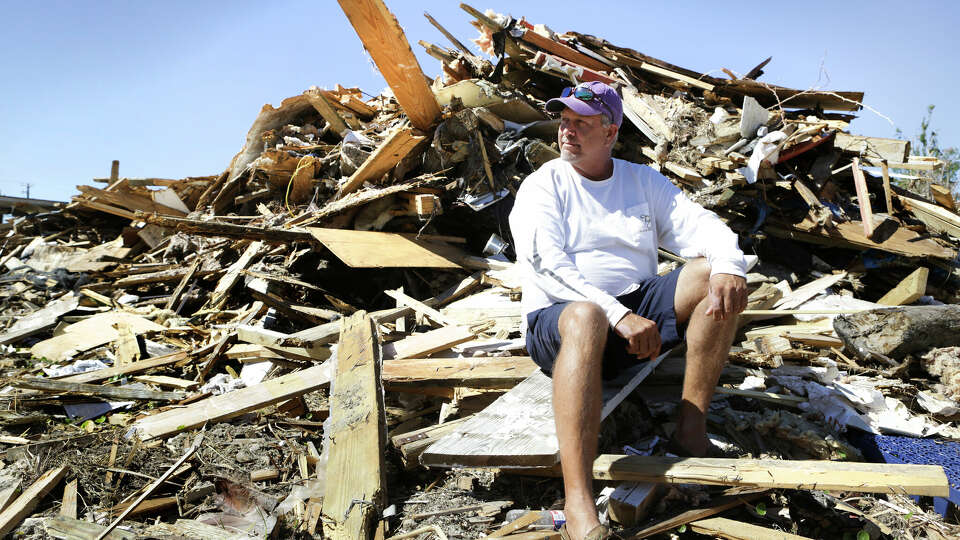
left=420, top=352, right=669, bottom=467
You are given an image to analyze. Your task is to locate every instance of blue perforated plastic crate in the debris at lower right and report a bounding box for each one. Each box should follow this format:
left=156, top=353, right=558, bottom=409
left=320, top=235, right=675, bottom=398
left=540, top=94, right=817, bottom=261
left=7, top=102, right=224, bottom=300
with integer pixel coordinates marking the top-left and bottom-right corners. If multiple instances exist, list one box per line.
left=847, top=430, right=960, bottom=517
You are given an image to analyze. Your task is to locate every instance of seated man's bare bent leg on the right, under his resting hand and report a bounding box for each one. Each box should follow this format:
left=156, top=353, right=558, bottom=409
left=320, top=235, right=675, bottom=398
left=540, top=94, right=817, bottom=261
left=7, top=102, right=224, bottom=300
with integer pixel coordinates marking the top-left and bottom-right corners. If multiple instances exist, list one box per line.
left=674, top=259, right=737, bottom=456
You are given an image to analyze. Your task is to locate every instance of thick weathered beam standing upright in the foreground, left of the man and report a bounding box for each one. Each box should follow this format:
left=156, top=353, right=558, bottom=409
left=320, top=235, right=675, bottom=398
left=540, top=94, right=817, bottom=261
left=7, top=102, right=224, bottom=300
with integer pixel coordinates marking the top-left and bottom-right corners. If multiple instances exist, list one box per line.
left=323, top=311, right=386, bottom=540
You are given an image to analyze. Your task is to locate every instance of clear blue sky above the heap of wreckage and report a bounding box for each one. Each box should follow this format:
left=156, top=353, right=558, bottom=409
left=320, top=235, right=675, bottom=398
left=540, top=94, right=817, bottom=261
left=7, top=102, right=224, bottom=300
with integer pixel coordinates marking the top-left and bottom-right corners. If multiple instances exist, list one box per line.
left=0, top=0, right=960, bottom=200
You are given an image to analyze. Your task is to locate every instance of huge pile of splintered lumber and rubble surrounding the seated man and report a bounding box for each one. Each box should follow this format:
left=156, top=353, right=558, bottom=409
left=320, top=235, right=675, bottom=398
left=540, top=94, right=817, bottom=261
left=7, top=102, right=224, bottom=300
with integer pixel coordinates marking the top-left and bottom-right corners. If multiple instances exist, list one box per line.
left=0, top=0, right=960, bottom=539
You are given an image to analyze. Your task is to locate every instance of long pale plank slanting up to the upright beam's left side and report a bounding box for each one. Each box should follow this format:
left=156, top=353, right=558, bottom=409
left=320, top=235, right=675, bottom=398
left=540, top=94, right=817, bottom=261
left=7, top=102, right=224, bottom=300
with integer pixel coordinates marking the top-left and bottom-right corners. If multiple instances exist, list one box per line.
left=133, top=365, right=330, bottom=441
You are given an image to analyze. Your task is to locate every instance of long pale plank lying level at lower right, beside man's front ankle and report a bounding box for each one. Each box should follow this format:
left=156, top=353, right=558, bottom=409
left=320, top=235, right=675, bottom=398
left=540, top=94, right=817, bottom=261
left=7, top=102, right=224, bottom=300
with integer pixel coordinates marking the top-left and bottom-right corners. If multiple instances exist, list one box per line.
left=593, top=454, right=950, bottom=497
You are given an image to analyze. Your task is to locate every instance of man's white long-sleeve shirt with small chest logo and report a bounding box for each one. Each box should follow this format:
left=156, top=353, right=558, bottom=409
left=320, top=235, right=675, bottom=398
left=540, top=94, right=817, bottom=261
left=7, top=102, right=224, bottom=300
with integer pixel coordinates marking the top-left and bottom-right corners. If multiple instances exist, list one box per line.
left=510, top=154, right=746, bottom=327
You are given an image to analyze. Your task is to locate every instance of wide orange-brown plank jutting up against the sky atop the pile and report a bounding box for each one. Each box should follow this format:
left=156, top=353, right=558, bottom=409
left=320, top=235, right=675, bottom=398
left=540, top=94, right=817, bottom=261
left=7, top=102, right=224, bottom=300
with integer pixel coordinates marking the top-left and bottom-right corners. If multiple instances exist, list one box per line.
left=338, top=0, right=440, bottom=131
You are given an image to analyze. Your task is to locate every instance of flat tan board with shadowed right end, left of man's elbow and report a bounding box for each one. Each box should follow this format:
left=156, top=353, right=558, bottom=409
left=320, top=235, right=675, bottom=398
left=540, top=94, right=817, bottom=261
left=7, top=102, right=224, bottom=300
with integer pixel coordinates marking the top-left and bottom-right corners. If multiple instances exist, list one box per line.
left=308, top=227, right=465, bottom=268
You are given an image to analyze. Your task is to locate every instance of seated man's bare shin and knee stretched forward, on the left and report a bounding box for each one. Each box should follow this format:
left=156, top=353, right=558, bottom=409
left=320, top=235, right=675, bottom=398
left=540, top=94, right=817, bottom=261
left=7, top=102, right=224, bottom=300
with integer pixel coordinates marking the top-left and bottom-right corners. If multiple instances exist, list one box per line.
left=553, top=302, right=609, bottom=539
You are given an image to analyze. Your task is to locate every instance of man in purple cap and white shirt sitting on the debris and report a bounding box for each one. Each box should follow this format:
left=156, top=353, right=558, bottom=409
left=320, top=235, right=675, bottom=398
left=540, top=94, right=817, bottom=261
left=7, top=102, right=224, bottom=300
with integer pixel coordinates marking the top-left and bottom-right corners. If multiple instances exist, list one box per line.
left=510, top=82, right=746, bottom=540
